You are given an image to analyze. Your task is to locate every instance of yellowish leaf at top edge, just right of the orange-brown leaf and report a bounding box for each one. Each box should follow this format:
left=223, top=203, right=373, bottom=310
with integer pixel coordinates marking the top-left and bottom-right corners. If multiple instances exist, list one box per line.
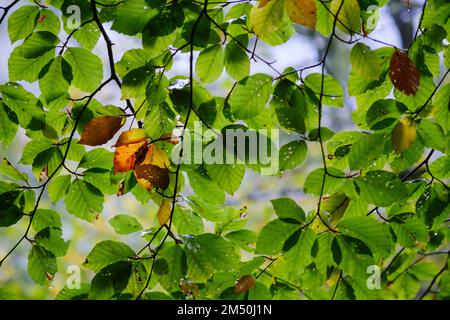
left=330, top=0, right=361, bottom=34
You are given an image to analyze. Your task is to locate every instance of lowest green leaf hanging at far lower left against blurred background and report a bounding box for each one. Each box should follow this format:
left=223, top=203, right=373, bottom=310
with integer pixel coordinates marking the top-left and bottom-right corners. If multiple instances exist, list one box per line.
left=28, top=245, right=57, bottom=285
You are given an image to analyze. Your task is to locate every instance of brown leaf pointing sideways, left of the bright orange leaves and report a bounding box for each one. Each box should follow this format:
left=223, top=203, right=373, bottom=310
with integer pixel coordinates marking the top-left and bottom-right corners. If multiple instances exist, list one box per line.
left=78, top=116, right=122, bottom=146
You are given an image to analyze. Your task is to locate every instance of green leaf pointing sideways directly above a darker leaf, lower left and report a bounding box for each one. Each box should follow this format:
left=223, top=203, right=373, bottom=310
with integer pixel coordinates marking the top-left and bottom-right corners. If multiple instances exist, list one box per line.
left=83, top=240, right=135, bottom=272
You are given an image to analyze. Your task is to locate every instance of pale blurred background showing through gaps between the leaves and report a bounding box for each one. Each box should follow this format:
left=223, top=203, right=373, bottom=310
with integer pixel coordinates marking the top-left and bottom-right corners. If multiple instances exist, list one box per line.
left=0, top=0, right=432, bottom=299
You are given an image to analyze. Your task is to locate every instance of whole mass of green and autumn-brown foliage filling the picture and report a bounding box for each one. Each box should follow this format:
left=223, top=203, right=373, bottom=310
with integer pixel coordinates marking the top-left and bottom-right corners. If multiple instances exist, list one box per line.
left=0, top=0, right=450, bottom=299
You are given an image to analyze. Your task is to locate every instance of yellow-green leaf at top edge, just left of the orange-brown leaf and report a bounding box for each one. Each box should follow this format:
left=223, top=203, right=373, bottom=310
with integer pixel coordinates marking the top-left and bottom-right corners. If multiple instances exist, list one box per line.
left=250, top=0, right=285, bottom=38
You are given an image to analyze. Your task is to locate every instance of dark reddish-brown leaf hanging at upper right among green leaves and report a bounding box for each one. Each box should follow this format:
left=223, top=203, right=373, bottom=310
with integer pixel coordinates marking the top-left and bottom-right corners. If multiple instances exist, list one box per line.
left=389, top=50, right=420, bottom=96
